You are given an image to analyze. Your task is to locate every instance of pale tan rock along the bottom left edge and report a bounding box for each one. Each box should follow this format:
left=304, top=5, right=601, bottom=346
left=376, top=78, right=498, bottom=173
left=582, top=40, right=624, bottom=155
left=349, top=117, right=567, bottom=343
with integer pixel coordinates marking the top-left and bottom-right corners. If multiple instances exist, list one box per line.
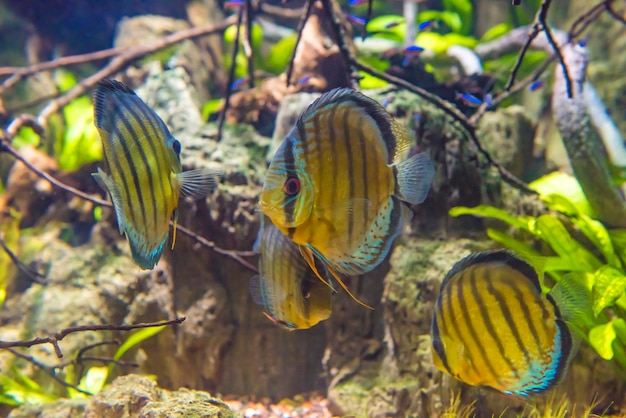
left=9, top=375, right=240, bottom=418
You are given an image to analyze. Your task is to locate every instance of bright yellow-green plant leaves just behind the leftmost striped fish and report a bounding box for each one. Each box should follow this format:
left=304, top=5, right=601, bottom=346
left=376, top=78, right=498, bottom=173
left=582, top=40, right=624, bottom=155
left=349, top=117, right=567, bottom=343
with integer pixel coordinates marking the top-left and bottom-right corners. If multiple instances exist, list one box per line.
left=13, top=69, right=102, bottom=171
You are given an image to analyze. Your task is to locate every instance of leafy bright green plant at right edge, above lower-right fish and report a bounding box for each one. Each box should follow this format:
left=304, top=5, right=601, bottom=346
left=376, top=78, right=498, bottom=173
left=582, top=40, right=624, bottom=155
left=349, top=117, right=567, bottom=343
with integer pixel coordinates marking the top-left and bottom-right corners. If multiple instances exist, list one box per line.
left=450, top=173, right=626, bottom=369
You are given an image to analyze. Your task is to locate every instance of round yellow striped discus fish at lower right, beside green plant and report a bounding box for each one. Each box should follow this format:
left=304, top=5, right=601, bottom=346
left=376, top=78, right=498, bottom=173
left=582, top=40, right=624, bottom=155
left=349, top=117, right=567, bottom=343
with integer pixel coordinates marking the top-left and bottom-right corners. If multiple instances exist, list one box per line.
left=432, top=251, right=579, bottom=396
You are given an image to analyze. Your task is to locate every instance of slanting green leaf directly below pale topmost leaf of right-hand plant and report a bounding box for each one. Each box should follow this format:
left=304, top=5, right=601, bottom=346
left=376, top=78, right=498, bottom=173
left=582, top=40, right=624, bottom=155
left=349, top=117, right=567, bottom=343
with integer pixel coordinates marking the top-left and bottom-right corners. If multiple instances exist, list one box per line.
left=534, top=215, right=602, bottom=271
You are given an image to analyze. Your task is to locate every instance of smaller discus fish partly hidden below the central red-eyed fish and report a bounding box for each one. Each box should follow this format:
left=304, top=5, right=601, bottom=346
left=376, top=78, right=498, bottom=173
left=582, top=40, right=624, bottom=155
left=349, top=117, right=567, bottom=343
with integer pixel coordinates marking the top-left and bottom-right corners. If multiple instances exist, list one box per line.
left=249, top=217, right=333, bottom=330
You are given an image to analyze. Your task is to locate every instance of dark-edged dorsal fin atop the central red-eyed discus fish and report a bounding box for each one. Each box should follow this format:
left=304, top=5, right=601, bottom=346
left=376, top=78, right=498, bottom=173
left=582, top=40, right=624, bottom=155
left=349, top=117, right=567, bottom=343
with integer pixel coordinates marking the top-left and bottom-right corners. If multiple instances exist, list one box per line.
left=297, top=88, right=412, bottom=164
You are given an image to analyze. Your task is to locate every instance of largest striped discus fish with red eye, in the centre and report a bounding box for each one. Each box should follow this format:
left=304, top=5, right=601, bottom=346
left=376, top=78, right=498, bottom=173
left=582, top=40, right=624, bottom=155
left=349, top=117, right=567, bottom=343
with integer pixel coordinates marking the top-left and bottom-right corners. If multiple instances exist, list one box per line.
left=259, top=88, right=435, bottom=306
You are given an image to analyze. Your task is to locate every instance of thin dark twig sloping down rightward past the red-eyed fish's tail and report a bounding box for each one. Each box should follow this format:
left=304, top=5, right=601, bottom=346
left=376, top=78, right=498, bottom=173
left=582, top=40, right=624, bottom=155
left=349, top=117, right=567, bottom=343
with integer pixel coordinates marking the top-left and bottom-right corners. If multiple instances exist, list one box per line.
left=354, top=61, right=537, bottom=194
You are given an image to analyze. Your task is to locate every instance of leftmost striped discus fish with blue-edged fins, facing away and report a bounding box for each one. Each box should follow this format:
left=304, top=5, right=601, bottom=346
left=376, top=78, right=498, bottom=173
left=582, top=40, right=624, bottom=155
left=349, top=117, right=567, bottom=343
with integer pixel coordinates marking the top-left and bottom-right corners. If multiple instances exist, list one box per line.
left=92, top=79, right=220, bottom=270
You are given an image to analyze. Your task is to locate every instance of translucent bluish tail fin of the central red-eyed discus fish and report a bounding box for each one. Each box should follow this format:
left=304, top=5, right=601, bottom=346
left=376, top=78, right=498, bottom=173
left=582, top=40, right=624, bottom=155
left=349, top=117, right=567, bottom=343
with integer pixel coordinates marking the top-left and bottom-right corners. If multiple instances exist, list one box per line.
left=393, top=152, right=435, bottom=204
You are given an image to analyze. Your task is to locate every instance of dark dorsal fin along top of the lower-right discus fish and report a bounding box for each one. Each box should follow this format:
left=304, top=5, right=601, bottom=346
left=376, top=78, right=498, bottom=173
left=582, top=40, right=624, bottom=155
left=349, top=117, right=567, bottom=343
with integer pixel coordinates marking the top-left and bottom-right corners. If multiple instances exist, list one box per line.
left=441, top=250, right=541, bottom=293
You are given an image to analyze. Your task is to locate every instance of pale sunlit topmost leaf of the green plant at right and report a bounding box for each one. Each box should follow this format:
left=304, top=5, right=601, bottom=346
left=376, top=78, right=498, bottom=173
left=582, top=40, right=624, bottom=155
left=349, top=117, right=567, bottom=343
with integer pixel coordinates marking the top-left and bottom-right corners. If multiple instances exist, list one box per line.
left=528, top=171, right=595, bottom=218
